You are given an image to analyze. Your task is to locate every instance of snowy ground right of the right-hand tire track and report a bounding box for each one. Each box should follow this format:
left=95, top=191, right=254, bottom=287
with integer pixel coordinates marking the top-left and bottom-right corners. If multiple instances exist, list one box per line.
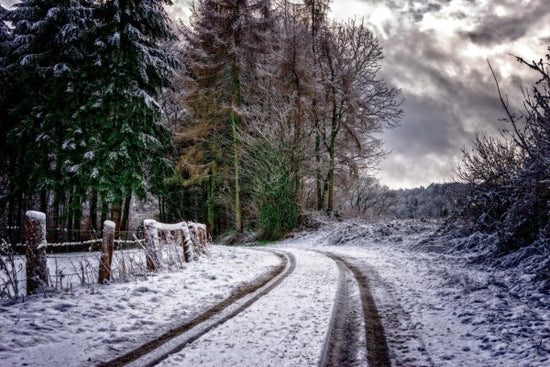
left=283, top=222, right=550, bottom=366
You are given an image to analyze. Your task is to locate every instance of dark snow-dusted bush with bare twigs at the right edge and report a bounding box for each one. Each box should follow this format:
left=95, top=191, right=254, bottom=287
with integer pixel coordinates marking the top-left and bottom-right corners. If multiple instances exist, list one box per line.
left=459, top=47, right=550, bottom=279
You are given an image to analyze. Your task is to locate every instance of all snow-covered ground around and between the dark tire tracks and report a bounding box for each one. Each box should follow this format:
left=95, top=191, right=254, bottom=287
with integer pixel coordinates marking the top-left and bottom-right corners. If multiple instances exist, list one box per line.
left=0, top=221, right=550, bottom=366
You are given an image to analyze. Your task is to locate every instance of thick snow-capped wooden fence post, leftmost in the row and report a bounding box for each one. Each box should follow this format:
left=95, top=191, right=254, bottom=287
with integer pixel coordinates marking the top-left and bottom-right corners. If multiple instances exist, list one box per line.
left=25, top=210, right=49, bottom=295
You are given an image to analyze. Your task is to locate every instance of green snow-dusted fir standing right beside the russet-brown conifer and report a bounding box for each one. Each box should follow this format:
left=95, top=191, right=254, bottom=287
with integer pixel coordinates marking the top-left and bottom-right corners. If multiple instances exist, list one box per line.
left=81, top=0, right=175, bottom=230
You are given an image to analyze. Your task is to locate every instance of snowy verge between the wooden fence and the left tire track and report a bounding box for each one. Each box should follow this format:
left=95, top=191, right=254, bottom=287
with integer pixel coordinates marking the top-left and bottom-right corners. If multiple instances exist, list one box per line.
left=0, top=246, right=280, bottom=366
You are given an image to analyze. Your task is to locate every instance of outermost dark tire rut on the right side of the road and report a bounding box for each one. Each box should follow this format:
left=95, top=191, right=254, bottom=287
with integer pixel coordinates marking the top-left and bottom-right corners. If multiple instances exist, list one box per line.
left=325, top=253, right=391, bottom=367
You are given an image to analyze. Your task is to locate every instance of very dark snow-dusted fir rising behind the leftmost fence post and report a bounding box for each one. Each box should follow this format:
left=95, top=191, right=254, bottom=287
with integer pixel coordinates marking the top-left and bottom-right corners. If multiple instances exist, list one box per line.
left=7, top=0, right=97, bottom=231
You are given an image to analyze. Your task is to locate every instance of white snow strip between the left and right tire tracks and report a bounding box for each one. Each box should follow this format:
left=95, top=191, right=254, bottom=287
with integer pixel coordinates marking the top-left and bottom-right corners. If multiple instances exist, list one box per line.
left=159, top=250, right=338, bottom=366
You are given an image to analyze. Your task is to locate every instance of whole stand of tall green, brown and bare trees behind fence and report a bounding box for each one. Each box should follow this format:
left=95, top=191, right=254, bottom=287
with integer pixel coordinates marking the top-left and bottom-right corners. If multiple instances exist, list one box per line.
left=0, top=0, right=402, bottom=238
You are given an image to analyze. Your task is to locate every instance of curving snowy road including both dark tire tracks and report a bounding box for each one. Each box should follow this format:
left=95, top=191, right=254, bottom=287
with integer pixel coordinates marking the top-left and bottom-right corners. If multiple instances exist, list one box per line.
left=101, top=249, right=391, bottom=367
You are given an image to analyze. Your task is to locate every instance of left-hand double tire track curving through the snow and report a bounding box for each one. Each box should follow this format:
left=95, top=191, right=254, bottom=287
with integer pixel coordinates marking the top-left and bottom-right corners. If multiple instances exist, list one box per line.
left=99, top=250, right=296, bottom=367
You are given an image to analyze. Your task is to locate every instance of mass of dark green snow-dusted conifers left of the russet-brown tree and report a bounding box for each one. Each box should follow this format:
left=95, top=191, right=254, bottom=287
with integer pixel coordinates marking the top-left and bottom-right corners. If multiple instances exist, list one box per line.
left=2, top=0, right=174, bottom=233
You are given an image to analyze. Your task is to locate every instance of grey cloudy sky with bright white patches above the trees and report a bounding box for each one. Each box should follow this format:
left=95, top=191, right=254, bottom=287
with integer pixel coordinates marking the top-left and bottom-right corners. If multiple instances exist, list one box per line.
left=0, top=0, right=550, bottom=188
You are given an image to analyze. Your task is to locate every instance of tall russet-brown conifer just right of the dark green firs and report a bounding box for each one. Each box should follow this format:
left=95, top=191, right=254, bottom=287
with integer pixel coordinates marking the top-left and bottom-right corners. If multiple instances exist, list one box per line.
left=183, top=0, right=271, bottom=232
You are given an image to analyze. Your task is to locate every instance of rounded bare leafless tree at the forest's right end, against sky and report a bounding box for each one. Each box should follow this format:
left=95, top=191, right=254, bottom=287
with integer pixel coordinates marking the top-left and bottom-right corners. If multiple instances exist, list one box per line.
left=320, top=20, right=402, bottom=210
